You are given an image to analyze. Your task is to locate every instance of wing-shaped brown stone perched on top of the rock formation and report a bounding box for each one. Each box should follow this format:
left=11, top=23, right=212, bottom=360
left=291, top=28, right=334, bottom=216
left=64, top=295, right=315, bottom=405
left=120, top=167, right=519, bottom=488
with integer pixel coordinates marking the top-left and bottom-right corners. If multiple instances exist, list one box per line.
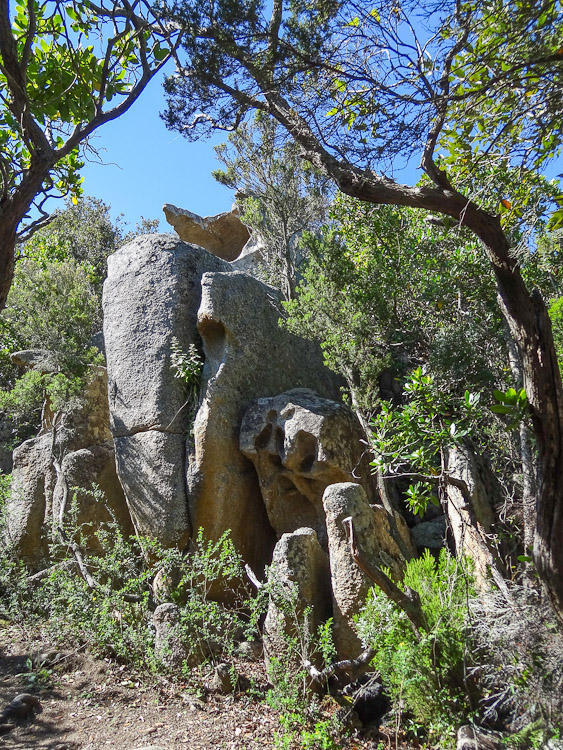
left=162, top=203, right=250, bottom=261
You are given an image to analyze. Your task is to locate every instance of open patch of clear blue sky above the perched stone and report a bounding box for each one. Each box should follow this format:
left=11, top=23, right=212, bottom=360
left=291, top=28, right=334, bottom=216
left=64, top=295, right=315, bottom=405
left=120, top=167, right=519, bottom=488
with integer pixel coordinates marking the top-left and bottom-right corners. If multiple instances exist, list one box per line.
left=82, top=69, right=234, bottom=231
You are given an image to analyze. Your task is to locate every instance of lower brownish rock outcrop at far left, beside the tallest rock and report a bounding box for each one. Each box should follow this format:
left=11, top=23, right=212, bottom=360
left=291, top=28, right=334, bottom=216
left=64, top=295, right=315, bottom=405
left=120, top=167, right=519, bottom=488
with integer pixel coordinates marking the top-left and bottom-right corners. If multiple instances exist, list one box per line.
left=5, top=367, right=132, bottom=568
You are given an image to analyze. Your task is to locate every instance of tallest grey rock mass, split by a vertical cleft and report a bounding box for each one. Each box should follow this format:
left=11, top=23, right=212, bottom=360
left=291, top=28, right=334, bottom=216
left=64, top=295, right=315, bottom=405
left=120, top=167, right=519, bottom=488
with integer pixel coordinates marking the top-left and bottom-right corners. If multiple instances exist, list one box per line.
left=104, top=235, right=338, bottom=569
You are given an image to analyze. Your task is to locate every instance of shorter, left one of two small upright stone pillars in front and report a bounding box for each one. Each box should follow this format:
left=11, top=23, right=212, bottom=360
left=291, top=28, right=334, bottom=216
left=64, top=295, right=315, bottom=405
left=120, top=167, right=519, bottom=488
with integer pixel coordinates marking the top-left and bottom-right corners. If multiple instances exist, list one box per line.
left=264, top=528, right=332, bottom=663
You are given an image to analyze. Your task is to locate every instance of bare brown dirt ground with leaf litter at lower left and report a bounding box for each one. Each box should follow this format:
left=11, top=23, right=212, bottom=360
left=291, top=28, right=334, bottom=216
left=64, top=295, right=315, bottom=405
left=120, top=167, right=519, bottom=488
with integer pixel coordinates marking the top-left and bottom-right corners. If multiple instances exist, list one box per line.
left=0, top=626, right=419, bottom=750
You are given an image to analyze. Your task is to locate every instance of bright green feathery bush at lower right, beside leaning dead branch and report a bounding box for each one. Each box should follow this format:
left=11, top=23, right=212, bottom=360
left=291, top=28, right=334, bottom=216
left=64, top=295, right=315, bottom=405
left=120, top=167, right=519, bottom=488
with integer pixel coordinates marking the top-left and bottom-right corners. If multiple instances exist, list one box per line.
left=357, top=549, right=472, bottom=747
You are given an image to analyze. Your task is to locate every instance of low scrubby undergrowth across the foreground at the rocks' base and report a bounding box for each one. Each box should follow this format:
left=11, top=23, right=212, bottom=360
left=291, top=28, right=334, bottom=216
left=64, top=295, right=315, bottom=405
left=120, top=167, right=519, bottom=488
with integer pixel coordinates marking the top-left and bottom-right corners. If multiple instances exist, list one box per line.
left=0, top=476, right=563, bottom=750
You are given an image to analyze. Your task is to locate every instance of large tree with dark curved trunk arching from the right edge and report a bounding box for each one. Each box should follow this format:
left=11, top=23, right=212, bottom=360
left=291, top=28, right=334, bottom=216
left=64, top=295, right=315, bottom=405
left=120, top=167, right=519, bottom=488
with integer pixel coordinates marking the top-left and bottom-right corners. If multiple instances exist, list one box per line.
left=159, top=0, right=563, bottom=618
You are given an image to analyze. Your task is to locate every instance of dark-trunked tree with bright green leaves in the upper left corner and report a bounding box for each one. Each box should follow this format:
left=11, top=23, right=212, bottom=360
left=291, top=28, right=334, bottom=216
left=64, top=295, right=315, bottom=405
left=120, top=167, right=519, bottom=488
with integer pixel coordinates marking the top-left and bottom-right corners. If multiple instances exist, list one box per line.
left=0, top=0, right=180, bottom=309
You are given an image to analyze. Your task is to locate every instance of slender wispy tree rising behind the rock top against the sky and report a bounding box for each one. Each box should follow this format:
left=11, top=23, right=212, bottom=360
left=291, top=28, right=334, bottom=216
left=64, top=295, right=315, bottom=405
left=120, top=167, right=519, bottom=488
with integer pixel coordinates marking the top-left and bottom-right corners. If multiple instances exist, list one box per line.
left=213, top=116, right=331, bottom=300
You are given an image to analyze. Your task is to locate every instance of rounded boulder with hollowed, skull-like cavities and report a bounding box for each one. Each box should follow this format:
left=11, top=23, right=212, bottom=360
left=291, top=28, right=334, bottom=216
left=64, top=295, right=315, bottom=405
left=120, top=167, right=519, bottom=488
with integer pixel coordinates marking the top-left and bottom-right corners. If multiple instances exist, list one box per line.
left=240, top=388, right=371, bottom=548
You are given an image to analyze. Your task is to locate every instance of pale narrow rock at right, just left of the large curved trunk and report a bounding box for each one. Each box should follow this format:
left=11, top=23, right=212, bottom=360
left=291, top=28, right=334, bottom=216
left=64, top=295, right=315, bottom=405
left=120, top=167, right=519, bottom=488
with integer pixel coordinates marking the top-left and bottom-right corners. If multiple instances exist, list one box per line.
left=446, top=446, right=500, bottom=584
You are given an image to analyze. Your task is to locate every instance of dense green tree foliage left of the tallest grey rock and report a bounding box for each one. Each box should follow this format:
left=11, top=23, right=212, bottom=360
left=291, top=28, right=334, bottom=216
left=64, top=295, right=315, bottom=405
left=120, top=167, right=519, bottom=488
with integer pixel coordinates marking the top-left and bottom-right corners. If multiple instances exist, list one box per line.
left=0, top=197, right=158, bottom=450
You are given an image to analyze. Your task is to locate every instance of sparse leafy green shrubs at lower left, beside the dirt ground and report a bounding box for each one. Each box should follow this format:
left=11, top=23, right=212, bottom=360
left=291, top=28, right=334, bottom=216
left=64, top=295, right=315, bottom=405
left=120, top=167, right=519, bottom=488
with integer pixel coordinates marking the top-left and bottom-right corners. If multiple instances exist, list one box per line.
left=0, top=506, right=250, bottom=671
